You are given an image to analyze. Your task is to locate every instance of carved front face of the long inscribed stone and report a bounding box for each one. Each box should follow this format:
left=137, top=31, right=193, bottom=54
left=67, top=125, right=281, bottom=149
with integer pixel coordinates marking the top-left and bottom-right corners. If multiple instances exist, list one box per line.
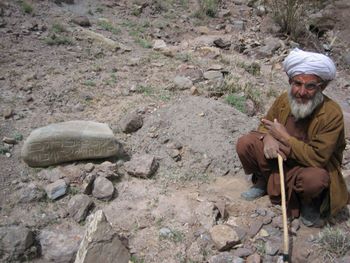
left=28, top=138, right=116, bottom=164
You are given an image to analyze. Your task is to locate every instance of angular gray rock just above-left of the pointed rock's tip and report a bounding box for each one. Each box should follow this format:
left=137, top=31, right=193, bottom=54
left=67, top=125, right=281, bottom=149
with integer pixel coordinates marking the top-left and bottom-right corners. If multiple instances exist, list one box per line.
left=68, top=194, right=94, bottom=223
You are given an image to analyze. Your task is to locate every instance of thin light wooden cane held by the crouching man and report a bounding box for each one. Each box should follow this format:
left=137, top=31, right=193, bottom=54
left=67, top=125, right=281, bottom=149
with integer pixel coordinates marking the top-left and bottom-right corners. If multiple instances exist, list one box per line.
left=277, top=154, right=289, bottom=262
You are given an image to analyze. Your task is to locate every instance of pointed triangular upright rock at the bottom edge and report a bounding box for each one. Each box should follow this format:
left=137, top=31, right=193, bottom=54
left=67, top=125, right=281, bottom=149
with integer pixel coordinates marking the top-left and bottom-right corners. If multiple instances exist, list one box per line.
left=75, top=210, right=130, bottom=263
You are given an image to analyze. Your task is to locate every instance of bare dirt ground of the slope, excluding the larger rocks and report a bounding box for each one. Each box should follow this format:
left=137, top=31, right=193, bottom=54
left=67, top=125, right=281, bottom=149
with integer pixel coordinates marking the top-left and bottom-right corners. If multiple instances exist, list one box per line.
left=0, top=0, right=350, bottom=263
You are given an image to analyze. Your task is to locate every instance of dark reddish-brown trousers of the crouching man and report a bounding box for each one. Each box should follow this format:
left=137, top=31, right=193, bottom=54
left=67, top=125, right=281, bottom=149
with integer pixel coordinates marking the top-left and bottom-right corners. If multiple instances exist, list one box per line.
left=236, top=132, right=330, bottom=217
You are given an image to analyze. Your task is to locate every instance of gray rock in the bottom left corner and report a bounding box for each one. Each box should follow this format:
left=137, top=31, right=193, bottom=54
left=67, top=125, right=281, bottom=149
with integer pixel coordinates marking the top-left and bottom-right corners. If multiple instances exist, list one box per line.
left=0, top=226, right=34, bottom=262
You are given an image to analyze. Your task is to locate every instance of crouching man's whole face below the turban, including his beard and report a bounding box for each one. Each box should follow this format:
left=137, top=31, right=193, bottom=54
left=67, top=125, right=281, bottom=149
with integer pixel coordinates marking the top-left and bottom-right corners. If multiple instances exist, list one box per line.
left=288, top=74, right=325, bottom=120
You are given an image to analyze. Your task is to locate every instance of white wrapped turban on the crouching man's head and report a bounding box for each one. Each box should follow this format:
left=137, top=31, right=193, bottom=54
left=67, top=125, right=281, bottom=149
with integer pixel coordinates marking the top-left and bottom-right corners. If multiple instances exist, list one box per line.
left=283, top=48, right=336, bottom=81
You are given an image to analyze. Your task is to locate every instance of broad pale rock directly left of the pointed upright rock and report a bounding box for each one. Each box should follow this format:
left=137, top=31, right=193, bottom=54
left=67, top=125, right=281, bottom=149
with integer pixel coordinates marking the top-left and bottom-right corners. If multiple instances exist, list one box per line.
left=39, top=225, right=83, bottom=263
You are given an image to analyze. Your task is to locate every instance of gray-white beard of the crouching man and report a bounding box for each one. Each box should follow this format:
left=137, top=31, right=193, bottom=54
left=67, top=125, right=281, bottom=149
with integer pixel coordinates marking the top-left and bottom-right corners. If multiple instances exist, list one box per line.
left=288, top=88, right=323, bottom=120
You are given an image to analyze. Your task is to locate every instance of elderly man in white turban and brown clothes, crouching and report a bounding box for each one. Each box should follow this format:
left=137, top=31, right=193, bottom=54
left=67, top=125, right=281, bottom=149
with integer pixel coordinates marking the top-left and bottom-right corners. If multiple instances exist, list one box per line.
left=237, top=49, right=348, bottom=226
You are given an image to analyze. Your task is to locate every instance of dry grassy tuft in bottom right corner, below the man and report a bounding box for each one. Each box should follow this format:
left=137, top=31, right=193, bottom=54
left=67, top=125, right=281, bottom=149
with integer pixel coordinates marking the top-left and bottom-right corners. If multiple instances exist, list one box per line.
left=315, top=226, right=350, bottom=262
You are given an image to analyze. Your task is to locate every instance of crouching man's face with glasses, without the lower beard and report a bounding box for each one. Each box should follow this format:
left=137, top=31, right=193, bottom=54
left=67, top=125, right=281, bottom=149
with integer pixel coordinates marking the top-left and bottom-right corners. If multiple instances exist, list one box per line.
left=290, top=74, right=321, bottom=104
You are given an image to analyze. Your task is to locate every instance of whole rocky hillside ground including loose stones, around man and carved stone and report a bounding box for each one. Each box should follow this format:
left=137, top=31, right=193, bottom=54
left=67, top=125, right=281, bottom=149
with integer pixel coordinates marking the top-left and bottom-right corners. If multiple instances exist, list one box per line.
left=0, top=0, right=350, bottom=263
